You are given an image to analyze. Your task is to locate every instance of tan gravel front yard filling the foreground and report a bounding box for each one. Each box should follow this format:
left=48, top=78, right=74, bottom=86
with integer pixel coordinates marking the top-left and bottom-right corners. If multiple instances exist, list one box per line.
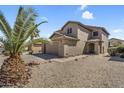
left=0, top=55, right=124, bottom=88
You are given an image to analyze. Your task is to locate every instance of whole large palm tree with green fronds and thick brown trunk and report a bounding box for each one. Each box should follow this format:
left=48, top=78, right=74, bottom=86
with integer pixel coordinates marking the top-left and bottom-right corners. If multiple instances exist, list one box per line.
left=0, top=7, right=46, bottom=86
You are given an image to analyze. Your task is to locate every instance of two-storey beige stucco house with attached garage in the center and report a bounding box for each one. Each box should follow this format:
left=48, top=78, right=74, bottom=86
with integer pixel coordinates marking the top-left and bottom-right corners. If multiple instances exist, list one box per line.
left=44, top=21, right=109, bottom=57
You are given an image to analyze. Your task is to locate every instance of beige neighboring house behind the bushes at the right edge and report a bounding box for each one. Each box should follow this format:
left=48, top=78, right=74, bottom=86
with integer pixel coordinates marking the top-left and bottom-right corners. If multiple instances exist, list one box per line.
left=109, top=38, right=124, bottom=47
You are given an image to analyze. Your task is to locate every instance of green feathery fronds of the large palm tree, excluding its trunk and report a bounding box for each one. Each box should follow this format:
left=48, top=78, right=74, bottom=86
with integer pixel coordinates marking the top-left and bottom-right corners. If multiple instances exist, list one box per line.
left=0, top=7, right=47, bottom=54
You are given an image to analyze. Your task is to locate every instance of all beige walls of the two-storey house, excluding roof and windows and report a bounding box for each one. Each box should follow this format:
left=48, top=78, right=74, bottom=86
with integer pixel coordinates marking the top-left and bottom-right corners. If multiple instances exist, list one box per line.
left=46, top=23, right=108, bottom=57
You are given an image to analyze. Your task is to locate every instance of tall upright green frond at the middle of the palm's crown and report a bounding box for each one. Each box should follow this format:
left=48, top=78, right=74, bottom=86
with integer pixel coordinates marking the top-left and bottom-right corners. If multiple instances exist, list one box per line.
left=14, top=7, right=36, bottom=51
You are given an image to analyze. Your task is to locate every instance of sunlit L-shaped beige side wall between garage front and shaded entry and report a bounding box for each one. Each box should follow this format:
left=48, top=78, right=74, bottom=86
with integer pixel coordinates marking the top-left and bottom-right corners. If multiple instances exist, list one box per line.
left=61, top=26, right=89, bottom=57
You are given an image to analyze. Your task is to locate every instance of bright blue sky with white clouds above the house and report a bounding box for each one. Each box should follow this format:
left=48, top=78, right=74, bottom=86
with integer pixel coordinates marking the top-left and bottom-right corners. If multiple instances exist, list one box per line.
left=0, top=5, right=124, bottom=39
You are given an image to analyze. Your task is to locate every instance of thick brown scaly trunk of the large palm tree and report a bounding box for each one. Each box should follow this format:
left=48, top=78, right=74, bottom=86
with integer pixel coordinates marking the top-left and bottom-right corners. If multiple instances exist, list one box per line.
left=0, top=54, right=30, bottom=87
